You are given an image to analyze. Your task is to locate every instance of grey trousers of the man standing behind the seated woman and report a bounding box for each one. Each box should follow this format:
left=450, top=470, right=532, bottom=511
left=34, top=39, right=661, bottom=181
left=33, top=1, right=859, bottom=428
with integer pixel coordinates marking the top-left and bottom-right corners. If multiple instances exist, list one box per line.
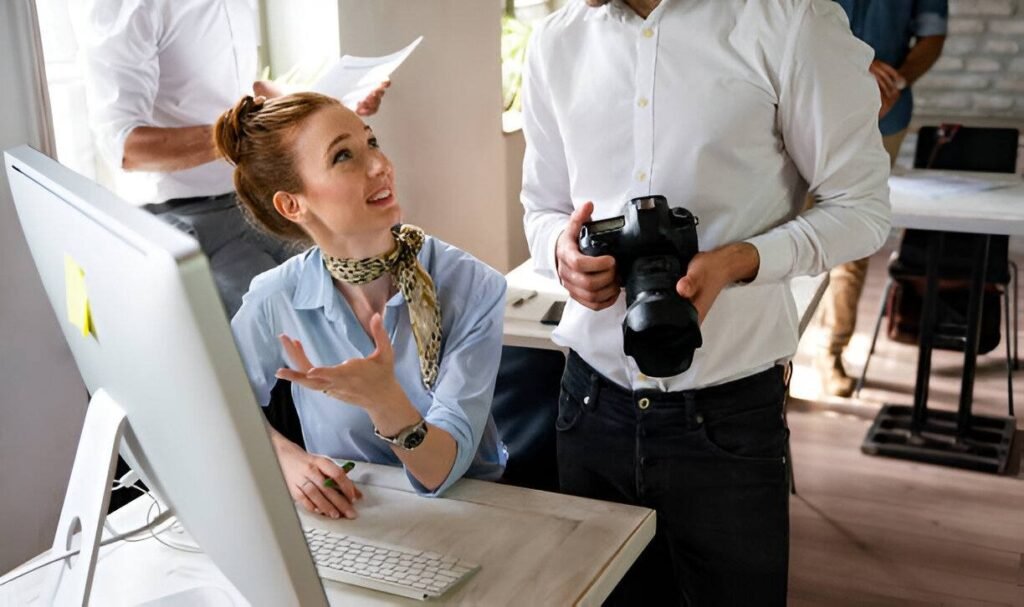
left=145, top=192, right=298, bottom=318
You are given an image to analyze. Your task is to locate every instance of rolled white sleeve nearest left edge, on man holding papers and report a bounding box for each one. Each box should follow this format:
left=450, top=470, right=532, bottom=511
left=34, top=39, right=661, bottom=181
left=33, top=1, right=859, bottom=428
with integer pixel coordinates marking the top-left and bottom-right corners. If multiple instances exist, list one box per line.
left=77, top=0, right=161, bottom=168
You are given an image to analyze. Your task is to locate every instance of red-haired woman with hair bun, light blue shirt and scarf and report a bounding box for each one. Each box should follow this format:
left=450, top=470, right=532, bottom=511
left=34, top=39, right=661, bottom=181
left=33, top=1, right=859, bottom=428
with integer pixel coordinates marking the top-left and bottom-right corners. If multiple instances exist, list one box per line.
left=214, top=93, right=507, bottom=518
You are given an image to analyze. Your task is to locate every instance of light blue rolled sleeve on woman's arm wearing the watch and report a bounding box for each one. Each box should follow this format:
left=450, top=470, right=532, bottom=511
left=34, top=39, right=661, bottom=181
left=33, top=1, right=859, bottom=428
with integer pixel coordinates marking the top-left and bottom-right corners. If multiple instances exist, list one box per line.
left=407, top=268, right=506, bottom=496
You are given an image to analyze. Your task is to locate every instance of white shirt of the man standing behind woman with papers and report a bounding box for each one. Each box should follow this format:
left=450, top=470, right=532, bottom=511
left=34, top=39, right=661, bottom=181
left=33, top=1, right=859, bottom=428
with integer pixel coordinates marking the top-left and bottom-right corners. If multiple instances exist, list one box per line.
left=76, top=0, right=259, bottom=203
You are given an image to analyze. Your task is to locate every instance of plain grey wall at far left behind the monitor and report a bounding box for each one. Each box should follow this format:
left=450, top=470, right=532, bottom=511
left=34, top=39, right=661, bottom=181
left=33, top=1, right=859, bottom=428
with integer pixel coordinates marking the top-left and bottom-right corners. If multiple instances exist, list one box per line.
left=0, top=0, right=87, bottom=571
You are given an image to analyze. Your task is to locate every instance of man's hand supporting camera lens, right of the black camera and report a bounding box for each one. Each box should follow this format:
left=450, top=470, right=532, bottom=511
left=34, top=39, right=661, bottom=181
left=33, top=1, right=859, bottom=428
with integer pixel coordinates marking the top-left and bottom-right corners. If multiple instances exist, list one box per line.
left=676, top=243, right=761, bottom=322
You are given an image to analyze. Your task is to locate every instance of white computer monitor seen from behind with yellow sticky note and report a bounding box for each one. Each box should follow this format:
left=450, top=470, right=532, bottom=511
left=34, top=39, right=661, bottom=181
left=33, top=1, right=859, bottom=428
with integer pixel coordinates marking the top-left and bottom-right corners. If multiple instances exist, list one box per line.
left=4, top=146, right=327, bottom=606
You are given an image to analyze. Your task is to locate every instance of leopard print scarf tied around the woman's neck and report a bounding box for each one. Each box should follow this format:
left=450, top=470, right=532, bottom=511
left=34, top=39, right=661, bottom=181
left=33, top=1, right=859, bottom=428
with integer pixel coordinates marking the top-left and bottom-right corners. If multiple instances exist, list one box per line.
left=324, top=225, right=441, bottom=389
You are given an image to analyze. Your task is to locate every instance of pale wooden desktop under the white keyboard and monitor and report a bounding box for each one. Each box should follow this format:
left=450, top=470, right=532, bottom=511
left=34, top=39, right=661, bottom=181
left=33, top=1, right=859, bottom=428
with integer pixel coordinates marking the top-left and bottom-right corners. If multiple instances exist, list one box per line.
left=0, top=464, right=654, bottom=607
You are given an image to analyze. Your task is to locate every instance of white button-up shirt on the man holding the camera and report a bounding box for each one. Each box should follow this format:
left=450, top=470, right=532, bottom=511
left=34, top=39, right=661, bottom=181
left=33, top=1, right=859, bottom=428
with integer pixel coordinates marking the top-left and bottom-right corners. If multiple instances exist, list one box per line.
left=522, top=0, right=890, bottom=391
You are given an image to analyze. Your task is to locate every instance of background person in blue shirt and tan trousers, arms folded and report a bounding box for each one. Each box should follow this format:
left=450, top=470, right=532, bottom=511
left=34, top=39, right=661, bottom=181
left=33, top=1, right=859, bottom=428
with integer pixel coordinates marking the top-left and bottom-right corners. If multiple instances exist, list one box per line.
left=816, top=0, right=949, bottom=397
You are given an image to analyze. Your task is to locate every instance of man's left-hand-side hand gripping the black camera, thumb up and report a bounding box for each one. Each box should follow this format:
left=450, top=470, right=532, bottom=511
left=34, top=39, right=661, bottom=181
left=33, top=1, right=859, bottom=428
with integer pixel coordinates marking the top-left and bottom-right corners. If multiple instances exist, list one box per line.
left=555, top=202, right=620, bottom=310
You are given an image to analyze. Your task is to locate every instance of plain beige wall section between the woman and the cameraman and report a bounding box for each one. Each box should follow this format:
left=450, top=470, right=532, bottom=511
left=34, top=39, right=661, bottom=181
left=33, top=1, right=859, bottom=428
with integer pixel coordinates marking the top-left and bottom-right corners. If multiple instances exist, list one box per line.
left=338, top=0, right=526, bottom=271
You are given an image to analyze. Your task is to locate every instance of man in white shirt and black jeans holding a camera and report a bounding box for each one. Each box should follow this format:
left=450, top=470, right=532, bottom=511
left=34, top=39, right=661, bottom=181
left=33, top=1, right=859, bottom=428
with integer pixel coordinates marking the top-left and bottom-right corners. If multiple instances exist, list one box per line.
left=522, top=0, right=890, bottom=606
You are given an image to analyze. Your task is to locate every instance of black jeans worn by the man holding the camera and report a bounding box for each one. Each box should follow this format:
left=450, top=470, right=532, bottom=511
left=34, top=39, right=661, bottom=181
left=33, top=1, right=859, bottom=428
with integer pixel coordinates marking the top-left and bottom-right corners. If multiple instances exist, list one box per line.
left=556, top=352, right=790, bottom=607
